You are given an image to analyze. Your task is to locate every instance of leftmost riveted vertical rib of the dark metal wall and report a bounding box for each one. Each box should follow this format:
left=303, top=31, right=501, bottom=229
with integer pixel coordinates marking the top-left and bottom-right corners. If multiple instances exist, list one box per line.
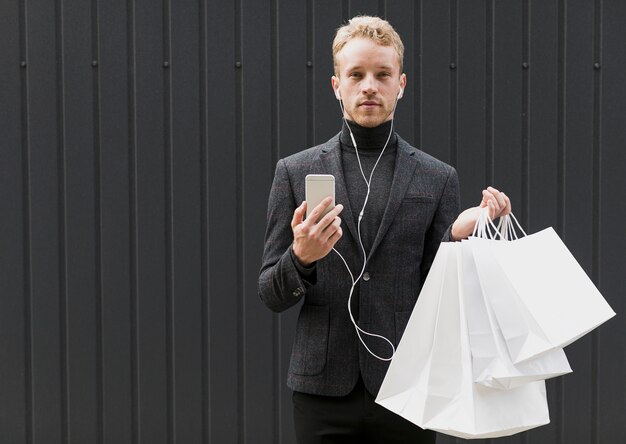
left=18, top=1, right=35, bottom=444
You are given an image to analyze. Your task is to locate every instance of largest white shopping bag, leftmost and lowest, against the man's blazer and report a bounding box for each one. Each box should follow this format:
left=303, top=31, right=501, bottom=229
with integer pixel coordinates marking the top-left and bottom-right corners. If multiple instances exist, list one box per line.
left=376, top=243, right=549, bottom=438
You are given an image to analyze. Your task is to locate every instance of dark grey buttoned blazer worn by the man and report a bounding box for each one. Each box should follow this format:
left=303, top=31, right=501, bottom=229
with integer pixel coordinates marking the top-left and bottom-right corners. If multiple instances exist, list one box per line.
left=259, top=135, right=459, bottom=396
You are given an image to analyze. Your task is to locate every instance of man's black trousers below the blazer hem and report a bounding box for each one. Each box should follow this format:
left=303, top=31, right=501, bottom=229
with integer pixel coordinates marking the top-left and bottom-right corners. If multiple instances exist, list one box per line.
left=293, top=377, right=435, bottom=444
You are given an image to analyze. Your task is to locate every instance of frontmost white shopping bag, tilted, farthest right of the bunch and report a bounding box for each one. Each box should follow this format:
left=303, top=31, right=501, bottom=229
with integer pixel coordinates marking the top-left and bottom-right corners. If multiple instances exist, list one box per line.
left=467, top=212, right=615, bottom=364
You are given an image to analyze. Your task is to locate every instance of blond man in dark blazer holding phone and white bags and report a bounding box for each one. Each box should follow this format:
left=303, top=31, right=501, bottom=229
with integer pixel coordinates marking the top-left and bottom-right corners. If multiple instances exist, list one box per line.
left=259, top=17, right=510, bottom=444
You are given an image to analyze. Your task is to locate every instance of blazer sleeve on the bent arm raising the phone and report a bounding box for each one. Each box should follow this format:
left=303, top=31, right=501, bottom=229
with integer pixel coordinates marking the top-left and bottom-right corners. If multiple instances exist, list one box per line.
left=258, top=160, right=316, bottom=312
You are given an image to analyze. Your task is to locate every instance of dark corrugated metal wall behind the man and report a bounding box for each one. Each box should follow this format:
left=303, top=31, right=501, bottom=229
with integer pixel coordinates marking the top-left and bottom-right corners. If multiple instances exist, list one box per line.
left=0, top=0, right=626, bottom=444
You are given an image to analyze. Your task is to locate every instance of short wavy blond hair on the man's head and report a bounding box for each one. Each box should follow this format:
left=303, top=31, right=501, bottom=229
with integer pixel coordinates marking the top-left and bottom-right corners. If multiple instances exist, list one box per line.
left=333, top=15, right=404, bottom=76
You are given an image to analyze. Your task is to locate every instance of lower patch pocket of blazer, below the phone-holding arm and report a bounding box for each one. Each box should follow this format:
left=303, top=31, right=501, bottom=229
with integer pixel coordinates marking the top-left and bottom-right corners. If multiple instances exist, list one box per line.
left=290, top=304, right=330, bottom=376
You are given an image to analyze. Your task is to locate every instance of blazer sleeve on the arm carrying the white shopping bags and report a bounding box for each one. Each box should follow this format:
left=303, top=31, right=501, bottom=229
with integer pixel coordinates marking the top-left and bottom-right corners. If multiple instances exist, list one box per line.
left=421, top=167, right=461, bottom=282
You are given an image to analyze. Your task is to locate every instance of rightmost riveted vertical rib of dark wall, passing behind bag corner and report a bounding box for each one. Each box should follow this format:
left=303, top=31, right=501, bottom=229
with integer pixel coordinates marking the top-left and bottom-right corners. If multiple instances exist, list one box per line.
left=591, top=0, right=603, bottom=444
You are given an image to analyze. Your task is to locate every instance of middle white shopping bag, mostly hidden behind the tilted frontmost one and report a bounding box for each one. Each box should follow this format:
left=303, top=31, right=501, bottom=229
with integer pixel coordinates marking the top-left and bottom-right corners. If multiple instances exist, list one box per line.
left=459, top=241, right=572, bottom=389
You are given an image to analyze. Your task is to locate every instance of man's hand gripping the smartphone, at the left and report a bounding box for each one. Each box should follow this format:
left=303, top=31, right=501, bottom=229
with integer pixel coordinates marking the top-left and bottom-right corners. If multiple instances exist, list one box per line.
left=291, top=196, right=343, bottom=267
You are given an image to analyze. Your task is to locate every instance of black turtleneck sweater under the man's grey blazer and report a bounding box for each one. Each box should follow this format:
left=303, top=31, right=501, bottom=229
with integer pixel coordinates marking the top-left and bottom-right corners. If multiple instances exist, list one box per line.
left=338, top=121, right=398, bottom=253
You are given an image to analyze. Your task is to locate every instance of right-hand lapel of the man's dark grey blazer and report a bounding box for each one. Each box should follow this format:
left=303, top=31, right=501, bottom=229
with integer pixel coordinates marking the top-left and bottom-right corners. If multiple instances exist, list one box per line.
left=367, top=137, right=417, bottom=261
